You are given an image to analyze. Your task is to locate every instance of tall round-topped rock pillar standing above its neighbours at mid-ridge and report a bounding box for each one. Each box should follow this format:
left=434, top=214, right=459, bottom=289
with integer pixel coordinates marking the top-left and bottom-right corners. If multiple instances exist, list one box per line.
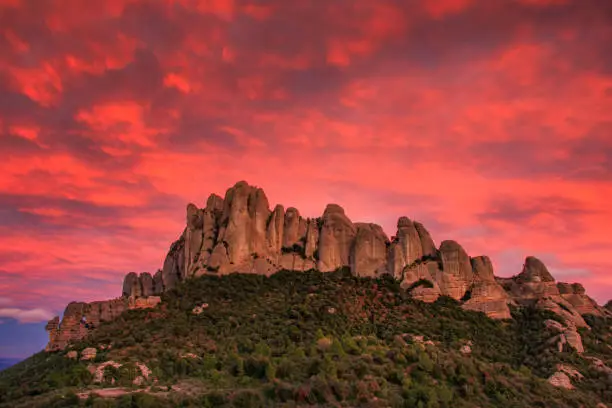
left=317, top=204, right=357, bottom=272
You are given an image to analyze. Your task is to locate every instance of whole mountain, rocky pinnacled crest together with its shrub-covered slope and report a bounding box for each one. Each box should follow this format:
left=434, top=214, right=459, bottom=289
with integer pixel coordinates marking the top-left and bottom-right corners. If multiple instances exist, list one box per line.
left=0, top=182, right=612, bottom=407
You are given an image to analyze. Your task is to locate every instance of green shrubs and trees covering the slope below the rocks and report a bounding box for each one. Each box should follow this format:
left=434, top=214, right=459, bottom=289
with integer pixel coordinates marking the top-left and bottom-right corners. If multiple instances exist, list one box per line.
left=0, top=270, right=612, bottom=408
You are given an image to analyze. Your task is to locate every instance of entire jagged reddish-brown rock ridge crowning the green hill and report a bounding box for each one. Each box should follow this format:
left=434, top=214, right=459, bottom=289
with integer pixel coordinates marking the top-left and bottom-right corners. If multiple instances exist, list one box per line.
left=47, top=181, right=610, bottom=349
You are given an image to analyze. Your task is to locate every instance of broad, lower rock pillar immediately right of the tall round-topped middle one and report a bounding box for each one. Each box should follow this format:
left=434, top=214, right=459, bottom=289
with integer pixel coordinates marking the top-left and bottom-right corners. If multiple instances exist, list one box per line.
left=350, top=223, right=389, bottom=277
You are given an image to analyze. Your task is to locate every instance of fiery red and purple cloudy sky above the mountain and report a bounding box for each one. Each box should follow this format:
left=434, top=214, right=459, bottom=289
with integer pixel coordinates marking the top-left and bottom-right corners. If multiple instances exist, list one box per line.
left=0, top=0, right=612, bottom=357
